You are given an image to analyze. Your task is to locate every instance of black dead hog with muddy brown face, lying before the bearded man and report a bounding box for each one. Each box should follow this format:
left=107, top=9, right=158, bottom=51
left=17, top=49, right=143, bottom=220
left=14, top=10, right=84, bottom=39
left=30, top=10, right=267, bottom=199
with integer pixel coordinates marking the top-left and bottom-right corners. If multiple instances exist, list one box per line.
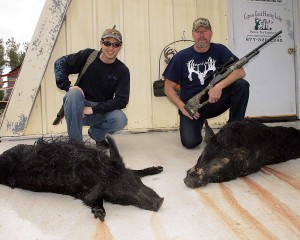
left=184, top=120, right=300, bottom=188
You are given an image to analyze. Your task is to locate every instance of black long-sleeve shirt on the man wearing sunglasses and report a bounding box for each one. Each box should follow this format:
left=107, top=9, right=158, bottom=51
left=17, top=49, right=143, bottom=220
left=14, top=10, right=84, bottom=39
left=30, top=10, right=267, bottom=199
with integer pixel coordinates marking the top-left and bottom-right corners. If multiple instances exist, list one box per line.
left=54, top=49, right=130, bottom=113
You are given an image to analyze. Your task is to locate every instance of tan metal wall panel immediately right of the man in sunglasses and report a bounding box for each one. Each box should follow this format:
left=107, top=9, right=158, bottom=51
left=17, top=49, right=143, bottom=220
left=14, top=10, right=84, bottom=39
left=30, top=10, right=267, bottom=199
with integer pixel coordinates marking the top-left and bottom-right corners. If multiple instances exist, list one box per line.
left=123, top=0, right=152, bottom=129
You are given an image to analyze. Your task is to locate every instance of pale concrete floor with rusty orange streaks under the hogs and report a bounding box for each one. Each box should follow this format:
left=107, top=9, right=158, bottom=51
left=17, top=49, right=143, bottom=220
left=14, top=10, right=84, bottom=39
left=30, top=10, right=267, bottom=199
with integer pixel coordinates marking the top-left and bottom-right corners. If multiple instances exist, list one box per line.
left=0, top=122, right=300, bottom=240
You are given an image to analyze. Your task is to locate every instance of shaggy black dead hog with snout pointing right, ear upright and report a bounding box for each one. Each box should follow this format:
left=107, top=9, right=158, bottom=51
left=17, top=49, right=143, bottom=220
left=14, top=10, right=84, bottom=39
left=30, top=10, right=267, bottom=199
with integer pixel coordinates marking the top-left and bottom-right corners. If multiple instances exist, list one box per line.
left=0, top=136, right=164, bottom=221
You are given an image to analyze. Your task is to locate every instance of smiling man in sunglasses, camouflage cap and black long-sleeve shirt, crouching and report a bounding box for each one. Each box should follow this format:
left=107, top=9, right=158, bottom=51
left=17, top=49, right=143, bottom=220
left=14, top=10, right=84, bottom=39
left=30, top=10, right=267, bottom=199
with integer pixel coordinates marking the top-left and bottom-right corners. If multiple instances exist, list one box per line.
left=54, top=27, right=130, bottom=148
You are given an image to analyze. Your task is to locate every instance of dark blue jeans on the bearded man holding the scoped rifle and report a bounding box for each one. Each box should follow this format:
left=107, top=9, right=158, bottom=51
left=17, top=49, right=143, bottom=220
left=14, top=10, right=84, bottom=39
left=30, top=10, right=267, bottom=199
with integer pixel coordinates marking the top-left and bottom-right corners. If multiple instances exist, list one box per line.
left=179, top=79, right=249, bottom=149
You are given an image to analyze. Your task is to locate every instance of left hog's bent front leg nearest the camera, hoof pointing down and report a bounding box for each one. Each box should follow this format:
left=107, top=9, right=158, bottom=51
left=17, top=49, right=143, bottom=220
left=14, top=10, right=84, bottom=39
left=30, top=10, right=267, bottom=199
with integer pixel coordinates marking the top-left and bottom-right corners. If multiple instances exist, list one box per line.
left=84, top=183, right=106, bottom=221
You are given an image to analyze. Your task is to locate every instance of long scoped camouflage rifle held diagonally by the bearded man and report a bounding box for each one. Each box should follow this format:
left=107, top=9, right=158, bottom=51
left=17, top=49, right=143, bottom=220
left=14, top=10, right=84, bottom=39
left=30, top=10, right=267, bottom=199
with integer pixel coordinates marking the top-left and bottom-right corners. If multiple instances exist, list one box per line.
left=184, top=30, right=282, bottom=117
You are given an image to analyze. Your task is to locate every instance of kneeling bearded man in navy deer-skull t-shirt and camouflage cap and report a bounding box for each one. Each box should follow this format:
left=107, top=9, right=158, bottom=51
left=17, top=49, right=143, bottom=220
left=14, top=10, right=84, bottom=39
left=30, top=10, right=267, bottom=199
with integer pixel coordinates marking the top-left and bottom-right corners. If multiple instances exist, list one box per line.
left=163, top=18, right=249, bottom=149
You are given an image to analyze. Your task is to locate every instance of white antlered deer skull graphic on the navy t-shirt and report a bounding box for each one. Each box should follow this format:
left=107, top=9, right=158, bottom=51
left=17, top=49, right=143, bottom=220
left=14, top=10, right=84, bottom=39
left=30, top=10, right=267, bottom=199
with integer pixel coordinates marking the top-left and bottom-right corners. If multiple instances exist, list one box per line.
left=186, top=57, right=216, bottom=85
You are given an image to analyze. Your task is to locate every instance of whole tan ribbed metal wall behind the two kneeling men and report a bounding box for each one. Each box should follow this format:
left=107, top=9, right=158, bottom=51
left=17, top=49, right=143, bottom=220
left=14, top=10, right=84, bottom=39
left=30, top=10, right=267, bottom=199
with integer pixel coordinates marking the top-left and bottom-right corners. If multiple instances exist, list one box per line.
left=20, top=0, right=228, bottom=135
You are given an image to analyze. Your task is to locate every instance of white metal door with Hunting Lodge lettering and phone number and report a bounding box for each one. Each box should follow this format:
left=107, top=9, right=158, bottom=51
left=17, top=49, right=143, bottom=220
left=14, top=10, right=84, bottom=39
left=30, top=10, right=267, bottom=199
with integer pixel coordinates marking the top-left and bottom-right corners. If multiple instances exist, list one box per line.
left=228, top=0, right=296, bottom=118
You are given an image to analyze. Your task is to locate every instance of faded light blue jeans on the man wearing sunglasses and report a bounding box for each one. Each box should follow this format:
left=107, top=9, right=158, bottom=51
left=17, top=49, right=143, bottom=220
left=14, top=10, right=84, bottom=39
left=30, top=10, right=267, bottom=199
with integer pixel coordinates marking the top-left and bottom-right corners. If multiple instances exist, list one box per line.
left=63, top=89, right=127, bottom=142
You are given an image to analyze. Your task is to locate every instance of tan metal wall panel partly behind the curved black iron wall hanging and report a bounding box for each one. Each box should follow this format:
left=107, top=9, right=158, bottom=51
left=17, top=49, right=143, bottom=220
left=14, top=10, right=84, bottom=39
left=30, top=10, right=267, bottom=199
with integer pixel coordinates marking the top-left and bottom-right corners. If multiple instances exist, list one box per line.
left=147, top=0, right=180, bottom=129
